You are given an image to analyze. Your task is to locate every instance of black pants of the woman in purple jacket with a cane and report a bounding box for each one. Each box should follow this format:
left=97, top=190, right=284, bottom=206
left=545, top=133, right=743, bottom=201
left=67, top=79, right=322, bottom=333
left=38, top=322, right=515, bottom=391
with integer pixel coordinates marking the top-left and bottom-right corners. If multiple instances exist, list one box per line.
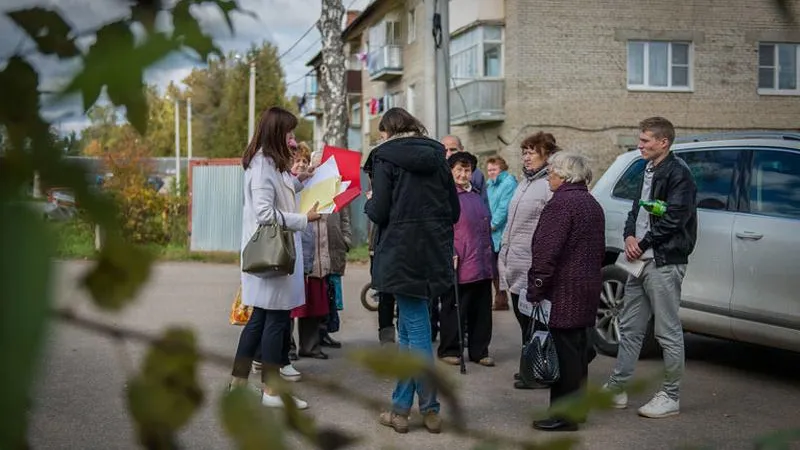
left=438, top=280, right=492, bottom=362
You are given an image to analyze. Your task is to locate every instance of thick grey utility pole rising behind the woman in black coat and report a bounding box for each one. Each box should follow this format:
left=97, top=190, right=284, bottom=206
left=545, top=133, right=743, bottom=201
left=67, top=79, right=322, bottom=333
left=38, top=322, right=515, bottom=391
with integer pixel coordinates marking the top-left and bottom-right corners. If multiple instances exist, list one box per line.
left=433, top=0, right=450, bottom=139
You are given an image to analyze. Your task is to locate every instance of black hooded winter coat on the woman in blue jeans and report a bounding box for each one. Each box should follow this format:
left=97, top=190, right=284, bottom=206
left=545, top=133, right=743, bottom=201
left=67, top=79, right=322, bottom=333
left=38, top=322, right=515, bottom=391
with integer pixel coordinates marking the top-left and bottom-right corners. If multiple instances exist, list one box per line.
left=364, top=137, right=461, bottom=299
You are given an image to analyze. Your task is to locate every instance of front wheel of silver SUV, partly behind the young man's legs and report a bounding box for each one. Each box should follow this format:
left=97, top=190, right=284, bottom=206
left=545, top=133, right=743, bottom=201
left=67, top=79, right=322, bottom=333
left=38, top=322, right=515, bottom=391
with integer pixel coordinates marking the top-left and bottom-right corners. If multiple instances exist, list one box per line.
left=593, top=265, right=659, bottom=358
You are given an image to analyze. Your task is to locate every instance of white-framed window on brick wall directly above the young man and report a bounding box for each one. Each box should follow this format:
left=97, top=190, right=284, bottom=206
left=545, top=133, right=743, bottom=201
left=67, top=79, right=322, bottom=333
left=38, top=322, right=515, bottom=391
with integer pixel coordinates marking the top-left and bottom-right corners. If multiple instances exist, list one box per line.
left=628, top=41, right=693, bottom=91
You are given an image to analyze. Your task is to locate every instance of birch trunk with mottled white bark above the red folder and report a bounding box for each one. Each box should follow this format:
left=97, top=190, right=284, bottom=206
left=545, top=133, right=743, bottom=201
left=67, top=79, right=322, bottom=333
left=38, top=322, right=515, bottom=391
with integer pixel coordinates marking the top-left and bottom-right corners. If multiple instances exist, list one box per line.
left=317, top=0, right=348, bottom=148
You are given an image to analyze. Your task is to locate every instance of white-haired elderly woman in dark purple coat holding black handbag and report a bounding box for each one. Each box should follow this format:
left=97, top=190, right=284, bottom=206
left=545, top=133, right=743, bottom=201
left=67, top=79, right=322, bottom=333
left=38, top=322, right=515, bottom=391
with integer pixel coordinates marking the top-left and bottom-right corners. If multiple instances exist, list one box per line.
left=527, top=153, right=605, bottom=431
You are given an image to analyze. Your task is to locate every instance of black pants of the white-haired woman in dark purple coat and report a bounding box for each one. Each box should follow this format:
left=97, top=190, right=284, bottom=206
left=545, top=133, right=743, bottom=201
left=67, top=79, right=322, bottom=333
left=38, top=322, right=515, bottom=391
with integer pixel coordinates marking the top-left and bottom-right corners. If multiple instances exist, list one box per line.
left=550, top=328, right=589, bottom=405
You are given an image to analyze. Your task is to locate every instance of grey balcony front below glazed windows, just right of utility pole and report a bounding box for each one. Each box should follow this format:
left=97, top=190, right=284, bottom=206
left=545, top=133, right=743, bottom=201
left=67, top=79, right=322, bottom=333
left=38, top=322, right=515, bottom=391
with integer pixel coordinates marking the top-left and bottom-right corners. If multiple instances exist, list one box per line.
left=450, top=78, right=506, bottom=126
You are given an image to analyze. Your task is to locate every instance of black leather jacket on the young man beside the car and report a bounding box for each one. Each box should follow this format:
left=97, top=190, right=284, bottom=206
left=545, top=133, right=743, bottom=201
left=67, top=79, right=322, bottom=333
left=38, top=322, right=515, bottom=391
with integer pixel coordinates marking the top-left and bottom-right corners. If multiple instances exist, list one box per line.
left=625, top=152, right=697, bottom=267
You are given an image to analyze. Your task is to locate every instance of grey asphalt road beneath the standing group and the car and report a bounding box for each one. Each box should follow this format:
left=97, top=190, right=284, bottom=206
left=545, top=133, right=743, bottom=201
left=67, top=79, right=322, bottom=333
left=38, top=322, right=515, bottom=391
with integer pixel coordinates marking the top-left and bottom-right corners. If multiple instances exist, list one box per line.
left=29, top=262, right=800, bottom=450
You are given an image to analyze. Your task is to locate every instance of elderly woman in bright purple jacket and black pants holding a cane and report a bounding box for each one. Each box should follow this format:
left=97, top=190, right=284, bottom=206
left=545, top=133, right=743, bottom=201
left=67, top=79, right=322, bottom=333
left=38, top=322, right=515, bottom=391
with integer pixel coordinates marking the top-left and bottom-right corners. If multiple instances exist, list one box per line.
left=438, top=152, right=494, bottom=367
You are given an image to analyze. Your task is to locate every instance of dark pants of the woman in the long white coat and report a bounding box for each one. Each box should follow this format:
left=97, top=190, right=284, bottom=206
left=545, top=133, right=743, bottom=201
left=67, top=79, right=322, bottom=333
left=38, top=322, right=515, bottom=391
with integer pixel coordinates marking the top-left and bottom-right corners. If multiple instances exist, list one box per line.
left=232, top=308, right=292, bottom=383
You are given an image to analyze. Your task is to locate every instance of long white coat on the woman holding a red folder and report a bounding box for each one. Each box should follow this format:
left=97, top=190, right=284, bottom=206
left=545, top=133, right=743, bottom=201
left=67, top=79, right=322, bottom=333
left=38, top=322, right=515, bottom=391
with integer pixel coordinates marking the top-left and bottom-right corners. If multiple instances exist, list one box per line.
left=242, top=150, right=308, bottom=311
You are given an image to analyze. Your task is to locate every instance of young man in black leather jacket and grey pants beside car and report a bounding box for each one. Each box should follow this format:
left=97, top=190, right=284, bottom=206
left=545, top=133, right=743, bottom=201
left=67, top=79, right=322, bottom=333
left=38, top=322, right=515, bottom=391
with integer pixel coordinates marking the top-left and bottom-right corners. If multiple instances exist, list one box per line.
left=606, top=117, right=697, bottom=418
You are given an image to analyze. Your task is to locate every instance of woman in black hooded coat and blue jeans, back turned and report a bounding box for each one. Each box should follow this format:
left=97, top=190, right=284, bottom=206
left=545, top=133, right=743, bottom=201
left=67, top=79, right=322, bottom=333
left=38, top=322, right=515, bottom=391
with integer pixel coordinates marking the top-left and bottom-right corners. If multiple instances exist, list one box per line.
left=364, top=108, right=461, bottom=433
